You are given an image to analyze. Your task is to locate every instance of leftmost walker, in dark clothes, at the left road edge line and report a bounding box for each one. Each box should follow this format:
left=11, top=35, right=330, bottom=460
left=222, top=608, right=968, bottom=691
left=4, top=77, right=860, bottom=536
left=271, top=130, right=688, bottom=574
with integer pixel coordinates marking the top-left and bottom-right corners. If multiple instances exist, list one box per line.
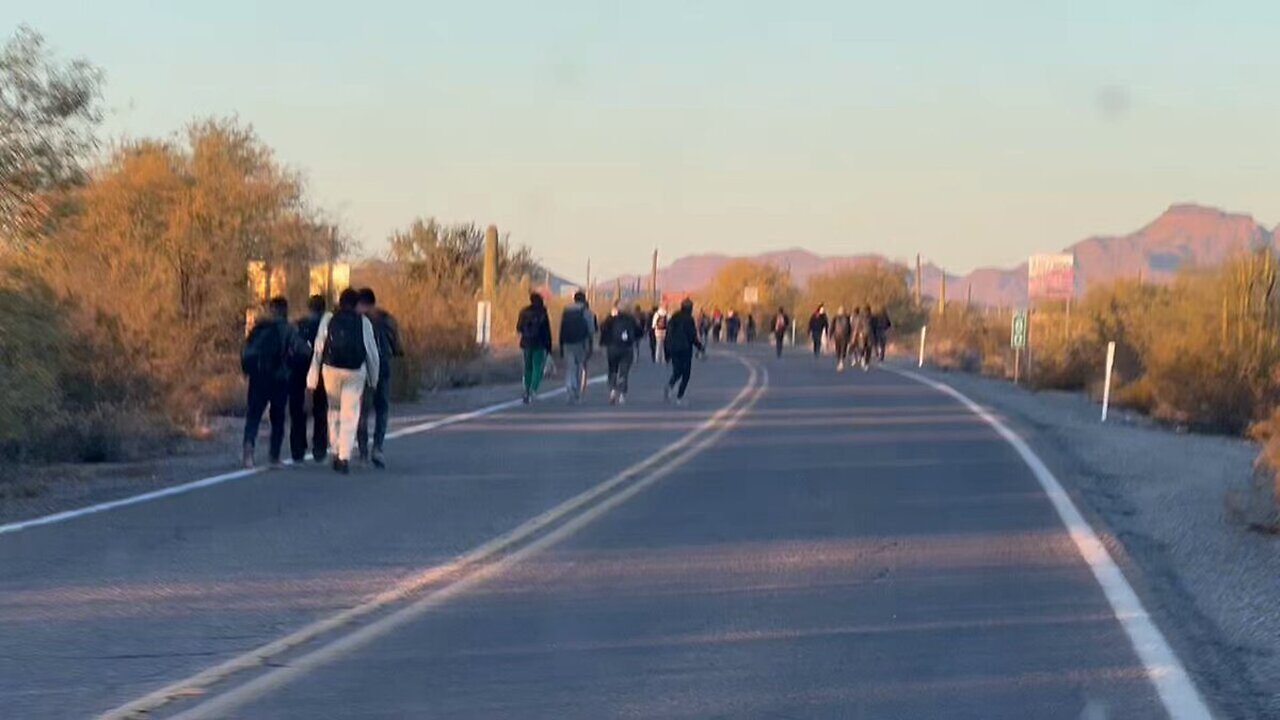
left=241, top=297, right=308, bottom=468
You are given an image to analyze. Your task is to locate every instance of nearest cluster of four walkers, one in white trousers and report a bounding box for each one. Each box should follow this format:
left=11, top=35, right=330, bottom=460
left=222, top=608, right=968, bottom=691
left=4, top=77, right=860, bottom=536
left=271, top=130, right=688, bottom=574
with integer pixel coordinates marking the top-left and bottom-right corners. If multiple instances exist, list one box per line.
left=241, top=287, right=404, bottom=473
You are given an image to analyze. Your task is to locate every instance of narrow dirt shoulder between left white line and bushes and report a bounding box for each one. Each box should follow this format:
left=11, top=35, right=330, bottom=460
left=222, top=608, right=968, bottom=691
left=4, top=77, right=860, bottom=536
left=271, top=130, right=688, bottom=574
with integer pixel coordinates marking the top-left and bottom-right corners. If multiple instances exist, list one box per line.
left=0, top=371, right=537, bottom=523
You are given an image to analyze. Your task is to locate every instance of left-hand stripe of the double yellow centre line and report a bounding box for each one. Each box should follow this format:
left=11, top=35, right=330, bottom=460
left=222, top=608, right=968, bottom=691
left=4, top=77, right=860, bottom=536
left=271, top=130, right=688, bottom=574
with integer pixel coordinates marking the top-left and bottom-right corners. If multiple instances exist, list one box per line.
left=99, top=359, right=768, bottom=720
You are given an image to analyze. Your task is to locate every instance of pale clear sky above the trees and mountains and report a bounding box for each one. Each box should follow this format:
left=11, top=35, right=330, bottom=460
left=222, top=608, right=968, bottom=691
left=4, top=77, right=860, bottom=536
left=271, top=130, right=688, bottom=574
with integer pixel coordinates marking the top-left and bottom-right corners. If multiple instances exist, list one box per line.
left=10, top=0, right=1280, bottom=277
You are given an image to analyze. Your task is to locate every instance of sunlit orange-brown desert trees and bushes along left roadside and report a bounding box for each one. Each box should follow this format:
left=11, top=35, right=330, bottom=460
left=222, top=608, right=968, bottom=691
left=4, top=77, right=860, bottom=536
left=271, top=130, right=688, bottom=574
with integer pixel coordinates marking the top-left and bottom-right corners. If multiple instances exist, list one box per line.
left=0, top=28, right=540, bottom=461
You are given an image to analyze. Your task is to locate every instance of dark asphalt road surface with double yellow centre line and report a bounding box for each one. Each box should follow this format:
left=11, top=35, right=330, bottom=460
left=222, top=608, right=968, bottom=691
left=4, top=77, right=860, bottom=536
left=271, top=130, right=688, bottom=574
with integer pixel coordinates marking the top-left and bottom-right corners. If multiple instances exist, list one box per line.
left=0, top=348, right=1194, bottom=720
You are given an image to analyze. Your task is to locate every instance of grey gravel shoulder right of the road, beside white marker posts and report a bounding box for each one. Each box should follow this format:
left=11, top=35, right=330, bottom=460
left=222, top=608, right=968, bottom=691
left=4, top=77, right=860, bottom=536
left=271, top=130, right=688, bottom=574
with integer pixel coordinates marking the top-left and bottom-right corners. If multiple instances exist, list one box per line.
left=924, top=370, right=1280, bottom=719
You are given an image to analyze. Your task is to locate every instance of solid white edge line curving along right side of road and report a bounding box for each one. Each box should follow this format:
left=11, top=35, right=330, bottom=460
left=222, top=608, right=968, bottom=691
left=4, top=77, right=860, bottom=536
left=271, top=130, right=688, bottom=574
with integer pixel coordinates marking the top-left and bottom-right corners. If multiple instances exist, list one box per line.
left=884, top=366, right=1213, bottom=720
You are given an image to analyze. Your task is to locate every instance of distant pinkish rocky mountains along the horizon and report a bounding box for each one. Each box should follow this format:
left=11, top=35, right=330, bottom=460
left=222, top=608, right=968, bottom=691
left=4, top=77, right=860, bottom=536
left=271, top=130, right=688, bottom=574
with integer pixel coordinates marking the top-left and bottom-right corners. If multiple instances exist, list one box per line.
left=600, top=204, right=1280, bottom=305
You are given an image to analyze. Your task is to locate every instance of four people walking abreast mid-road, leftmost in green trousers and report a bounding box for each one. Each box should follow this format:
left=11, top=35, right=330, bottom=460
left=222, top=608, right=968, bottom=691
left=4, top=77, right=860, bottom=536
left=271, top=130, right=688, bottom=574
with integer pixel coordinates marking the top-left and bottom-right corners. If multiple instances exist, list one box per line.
left=516, top=292, right=705, bottom=405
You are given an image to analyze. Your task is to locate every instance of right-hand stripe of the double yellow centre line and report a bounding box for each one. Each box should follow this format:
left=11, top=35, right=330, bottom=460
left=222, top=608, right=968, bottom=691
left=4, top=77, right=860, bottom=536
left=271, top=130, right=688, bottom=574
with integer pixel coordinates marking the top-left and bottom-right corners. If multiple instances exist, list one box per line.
left=173, top=366, right=769, bottom=720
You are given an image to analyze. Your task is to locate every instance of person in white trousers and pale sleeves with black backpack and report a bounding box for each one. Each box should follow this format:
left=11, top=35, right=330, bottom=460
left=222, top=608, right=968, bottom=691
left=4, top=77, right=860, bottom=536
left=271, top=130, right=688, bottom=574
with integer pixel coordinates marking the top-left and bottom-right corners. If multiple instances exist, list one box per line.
left=307, top=287, right=381, bottom=474
